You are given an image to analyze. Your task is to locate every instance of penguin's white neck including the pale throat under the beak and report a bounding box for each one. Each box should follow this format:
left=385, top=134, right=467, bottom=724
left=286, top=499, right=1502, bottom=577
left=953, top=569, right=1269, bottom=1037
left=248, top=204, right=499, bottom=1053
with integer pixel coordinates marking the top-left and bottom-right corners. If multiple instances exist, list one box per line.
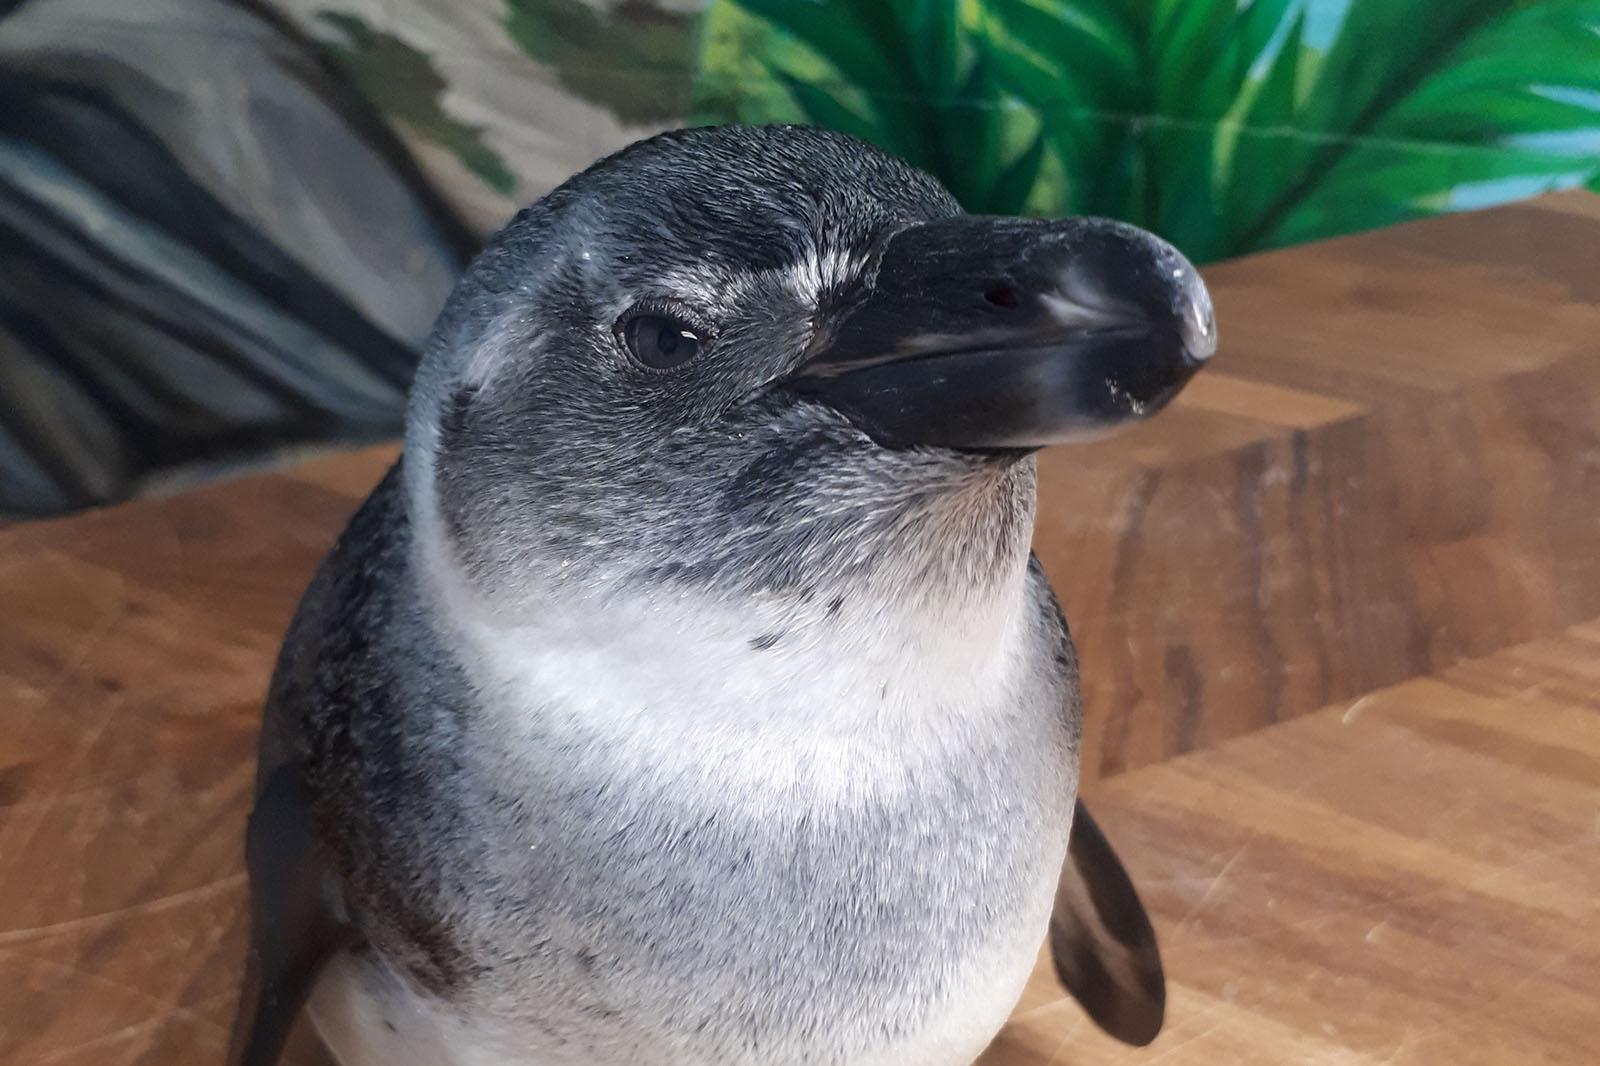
left=406, top=464, right=1040, bottom=743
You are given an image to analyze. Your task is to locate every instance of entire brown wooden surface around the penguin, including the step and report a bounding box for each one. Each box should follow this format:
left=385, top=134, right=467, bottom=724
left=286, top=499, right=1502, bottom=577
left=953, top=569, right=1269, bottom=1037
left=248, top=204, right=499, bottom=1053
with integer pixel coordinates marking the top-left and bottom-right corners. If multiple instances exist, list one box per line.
left=0, top=195, right=1600, bottom=1066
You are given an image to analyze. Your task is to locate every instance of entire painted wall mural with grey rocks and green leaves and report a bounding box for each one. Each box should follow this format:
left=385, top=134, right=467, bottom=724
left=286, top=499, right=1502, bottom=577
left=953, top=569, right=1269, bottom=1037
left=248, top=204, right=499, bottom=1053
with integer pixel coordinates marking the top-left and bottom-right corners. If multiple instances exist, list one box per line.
left=0, top=0, right=1600, bottom=520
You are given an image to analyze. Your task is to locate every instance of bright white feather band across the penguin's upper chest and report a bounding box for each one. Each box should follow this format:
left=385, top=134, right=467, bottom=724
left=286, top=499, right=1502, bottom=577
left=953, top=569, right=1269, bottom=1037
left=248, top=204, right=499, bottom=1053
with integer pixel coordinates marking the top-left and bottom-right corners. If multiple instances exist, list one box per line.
left=432, top=547, right=1051, bottom=794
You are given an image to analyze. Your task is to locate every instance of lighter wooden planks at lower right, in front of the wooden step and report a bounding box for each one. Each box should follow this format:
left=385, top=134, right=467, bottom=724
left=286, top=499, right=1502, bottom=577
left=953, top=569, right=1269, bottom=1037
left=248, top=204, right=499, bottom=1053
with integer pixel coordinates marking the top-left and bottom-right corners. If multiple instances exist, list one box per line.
left=984, top=623, right=1600, bottom=1066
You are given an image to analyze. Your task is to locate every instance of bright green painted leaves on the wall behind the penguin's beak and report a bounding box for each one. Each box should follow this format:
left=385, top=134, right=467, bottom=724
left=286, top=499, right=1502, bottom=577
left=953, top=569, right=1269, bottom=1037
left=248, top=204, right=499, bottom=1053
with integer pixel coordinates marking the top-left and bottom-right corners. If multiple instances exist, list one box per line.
left=694, top=0, right=1600, bottom=261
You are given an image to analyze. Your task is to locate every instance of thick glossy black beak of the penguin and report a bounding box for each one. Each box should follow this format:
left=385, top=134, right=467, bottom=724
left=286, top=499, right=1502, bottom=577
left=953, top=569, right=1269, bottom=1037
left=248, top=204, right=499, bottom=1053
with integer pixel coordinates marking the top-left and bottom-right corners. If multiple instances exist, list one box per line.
left=784, top=214, right=1216, bottom=451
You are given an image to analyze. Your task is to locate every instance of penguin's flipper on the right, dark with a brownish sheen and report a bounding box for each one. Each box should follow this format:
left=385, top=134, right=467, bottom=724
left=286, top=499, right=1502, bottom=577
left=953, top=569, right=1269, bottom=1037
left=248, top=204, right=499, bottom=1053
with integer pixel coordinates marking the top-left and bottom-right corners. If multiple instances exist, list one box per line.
left=1050, top=800, right=1166, bottom=1047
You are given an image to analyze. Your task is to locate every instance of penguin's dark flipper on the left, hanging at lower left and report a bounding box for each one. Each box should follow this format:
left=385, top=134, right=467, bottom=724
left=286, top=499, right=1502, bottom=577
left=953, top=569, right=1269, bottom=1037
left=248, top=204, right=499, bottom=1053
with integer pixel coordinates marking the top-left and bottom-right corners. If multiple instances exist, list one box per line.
left=227, top=762, right=350, bottom=1066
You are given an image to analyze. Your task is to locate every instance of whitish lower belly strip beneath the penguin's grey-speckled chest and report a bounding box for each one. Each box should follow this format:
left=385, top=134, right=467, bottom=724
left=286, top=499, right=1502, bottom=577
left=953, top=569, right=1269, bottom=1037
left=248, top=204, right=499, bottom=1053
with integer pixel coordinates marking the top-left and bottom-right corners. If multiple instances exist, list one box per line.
left=309, top=877, right=1045, bottom=1066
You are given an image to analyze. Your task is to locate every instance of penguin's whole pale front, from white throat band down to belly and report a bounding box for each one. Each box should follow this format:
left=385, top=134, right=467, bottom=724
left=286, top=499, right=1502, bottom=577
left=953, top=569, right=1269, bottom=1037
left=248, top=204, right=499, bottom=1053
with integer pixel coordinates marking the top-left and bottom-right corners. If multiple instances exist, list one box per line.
left=332, top=550, right=1077, bottom=1066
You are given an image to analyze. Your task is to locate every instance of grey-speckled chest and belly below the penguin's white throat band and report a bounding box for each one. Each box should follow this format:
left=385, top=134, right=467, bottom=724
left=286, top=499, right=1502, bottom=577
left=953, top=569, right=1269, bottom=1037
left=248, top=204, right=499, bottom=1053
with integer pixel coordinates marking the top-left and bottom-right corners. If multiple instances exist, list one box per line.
left=314, top=697, right=1075, bottom=1066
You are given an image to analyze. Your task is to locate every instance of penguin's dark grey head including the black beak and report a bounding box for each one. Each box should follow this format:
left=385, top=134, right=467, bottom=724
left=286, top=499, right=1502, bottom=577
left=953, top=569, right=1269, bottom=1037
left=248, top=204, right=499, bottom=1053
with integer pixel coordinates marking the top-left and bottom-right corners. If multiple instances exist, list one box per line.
left=405, top=126, right=1214, bottom=599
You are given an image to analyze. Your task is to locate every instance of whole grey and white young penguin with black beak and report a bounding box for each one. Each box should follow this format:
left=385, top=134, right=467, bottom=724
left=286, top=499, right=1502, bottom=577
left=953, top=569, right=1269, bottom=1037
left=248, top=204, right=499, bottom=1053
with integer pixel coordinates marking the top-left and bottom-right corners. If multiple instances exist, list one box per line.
left=230, top=126, right=1216, bottom=1066
